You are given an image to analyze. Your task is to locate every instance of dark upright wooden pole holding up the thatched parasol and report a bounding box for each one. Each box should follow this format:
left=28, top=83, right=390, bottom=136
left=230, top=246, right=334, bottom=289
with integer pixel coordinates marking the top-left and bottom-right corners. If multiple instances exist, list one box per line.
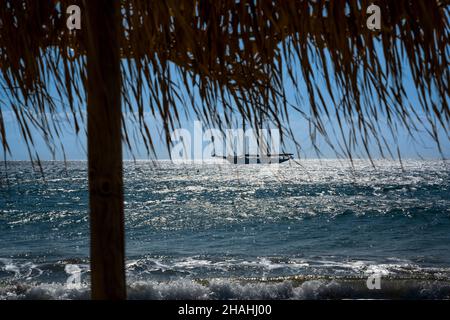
left=86, top=0, right=126, bottom=299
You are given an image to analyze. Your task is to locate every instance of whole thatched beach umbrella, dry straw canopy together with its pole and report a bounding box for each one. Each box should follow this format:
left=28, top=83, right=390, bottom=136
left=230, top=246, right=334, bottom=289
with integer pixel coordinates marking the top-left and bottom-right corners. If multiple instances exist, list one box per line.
left=0, top=0, right=450, bottom=298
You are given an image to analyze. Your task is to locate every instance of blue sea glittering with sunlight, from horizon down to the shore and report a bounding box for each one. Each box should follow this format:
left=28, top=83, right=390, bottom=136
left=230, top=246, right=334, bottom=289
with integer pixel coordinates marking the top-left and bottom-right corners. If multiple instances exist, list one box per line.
left=0, top=160, right=450, bottom=299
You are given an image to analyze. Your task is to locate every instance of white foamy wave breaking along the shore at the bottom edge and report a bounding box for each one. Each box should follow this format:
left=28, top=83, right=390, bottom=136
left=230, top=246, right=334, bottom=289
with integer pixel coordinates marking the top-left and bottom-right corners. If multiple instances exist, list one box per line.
left=0, top=279, right=450, bottom=300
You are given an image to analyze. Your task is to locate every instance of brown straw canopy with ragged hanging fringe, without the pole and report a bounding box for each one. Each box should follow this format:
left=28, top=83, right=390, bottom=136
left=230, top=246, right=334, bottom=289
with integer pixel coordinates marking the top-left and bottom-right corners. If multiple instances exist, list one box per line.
left=0, top=0, right=450, bottom=157
